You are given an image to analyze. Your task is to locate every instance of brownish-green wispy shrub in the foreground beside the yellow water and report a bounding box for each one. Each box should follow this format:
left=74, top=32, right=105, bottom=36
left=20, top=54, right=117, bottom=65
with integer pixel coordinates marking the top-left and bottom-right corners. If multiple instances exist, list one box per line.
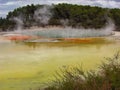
left=44, top=53, right=120, bottom=90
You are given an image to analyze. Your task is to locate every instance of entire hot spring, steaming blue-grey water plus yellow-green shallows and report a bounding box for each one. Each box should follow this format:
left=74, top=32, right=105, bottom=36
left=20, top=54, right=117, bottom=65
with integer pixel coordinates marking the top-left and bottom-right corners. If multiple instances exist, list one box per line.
left=0, top=21, right=120, bottom=90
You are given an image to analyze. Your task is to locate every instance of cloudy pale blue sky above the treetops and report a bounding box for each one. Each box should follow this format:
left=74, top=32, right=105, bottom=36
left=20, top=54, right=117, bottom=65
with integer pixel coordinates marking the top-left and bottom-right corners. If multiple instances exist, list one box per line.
left=0, top=0, right=120, bottom=17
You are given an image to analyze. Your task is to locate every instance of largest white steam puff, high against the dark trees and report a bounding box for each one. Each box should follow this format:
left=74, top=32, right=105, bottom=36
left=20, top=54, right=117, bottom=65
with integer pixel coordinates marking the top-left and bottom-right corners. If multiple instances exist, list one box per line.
left=34, top=5, right=52, bottom=25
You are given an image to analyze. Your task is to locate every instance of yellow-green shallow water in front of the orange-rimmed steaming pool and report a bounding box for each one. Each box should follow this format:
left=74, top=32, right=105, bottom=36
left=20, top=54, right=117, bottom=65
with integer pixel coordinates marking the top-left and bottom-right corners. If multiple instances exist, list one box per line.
left=0, top=38, right=120, bottom=90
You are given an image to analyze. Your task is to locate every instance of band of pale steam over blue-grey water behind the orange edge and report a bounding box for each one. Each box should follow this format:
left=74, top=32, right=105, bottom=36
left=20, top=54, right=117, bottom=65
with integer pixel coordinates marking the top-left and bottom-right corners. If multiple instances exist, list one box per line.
left=24, top=22, right=114, bottom=38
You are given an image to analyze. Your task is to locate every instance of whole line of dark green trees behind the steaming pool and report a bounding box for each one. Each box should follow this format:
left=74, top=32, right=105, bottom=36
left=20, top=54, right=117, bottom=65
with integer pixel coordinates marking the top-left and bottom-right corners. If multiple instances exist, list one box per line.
left=0, top=3, right=120, bottom=31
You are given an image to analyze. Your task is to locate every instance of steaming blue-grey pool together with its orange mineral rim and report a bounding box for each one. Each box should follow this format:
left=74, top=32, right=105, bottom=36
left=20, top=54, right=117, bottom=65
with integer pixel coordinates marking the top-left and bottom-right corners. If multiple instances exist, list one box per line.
left=3, top=24, right=114, bottom=42
